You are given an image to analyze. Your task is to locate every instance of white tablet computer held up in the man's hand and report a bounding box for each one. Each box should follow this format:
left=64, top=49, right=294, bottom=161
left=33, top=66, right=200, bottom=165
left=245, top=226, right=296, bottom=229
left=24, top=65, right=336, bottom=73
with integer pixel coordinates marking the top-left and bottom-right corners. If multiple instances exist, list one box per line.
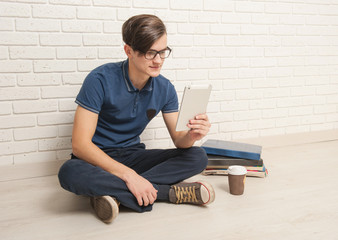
left=176, top=84, right=211, bottom=131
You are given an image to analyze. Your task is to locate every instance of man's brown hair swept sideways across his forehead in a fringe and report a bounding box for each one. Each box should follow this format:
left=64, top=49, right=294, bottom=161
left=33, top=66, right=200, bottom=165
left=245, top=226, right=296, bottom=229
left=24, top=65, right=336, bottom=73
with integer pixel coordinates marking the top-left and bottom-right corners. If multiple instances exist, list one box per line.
left=122, top=14, right=167, bottom=53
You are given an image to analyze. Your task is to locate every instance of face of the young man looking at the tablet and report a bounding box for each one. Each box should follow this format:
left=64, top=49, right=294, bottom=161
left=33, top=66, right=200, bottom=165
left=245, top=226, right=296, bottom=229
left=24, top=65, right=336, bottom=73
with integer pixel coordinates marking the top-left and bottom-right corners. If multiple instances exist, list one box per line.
left=128, top=34, right=167, bottom=80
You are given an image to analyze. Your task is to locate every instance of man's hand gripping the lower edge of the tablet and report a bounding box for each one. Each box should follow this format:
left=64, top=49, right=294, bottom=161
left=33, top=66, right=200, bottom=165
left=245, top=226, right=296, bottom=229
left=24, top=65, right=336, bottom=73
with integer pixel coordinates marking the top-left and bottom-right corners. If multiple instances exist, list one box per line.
left=187, top=114, right=211, bottom=141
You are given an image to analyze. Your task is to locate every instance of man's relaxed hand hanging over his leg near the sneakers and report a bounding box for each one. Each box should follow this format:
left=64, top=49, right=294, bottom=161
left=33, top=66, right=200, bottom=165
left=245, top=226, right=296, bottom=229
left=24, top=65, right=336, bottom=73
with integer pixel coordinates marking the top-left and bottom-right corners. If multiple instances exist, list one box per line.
left=125, top=171, right=157, bottom=206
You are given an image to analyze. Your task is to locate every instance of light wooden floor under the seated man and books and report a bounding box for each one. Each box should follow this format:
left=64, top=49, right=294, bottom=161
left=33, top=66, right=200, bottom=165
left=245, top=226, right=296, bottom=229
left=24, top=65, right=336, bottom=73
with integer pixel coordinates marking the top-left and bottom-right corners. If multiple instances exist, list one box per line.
left=0, top=141, right=338, bottom=240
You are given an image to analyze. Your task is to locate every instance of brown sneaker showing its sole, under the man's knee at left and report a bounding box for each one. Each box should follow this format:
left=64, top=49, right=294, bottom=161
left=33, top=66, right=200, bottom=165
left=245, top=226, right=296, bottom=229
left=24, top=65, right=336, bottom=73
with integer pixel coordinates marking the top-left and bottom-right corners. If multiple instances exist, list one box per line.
left=90, top=196, right=120, bottom=223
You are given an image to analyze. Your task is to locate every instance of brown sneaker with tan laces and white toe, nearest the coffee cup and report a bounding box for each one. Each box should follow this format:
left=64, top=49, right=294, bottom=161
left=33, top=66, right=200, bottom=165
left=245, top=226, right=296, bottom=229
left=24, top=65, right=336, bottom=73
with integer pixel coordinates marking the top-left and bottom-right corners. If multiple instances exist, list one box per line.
left=169, top=182, right=215, bottom=205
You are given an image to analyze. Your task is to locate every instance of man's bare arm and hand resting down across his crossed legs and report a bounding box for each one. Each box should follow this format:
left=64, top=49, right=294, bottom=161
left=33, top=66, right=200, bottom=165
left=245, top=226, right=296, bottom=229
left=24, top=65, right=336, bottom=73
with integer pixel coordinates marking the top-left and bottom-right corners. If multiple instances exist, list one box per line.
left=72, top=106, right=157, bottom=206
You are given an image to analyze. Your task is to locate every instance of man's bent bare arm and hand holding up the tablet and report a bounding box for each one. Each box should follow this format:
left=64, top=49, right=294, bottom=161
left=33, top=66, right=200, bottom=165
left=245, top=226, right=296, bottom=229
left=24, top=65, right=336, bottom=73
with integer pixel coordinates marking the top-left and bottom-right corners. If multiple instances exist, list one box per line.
left=163, top=112, right=211, bottom=148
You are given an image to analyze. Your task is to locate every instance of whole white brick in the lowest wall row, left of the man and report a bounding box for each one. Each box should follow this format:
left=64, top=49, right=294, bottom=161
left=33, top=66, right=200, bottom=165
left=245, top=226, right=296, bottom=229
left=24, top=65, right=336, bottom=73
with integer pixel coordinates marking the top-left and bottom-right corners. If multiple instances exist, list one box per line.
left=14, top=151, right=57, bottom=164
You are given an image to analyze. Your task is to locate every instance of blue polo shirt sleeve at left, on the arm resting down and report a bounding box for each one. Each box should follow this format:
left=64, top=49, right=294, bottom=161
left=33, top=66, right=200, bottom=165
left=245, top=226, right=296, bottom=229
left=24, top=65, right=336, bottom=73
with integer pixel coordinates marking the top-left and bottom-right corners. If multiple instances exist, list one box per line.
left=75, top=73, right=104, bottom=114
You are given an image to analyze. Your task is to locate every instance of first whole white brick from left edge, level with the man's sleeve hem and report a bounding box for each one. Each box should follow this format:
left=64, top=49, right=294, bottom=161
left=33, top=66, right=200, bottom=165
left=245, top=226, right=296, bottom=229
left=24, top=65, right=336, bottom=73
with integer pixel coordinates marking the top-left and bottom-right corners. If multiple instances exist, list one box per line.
left=13, top=100, right=58, bottom=113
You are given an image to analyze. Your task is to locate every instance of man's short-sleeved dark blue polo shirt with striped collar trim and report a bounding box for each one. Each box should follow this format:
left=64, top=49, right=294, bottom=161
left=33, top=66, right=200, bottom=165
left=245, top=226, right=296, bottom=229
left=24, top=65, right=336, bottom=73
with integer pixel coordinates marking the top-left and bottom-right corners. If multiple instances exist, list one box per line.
left=75, top=60, right=178, bottom=149
